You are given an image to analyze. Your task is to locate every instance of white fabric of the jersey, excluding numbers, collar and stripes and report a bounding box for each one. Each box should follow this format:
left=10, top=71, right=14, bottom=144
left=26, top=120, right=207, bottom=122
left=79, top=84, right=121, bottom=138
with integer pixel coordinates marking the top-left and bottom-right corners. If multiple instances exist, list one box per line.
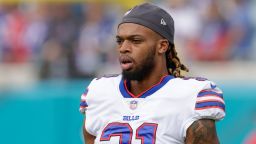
left=81, top=75, right=225, bottom=144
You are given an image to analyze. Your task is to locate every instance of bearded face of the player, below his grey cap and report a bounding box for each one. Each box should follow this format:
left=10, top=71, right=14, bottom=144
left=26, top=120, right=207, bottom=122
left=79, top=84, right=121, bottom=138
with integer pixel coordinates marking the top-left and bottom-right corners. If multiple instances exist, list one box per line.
left=116, top=23, right=159, bottom=81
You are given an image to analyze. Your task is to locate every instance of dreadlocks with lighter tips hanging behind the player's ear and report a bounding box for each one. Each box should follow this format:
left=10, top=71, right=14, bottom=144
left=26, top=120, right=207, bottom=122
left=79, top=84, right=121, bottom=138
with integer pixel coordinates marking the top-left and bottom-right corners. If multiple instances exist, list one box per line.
left=165, top=44, right=189, bottom=78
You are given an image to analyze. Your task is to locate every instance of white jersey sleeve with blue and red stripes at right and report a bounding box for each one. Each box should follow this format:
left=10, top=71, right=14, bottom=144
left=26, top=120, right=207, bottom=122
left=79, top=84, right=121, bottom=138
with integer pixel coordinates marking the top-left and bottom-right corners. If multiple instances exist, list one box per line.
left=182, top=81, right=225, bottom=137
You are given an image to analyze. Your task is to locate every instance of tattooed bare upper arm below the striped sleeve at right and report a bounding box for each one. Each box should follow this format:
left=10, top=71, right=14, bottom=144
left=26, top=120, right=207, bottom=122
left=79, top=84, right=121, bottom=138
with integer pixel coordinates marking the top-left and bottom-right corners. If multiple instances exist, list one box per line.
left=185, top=119, right=219, bottom=144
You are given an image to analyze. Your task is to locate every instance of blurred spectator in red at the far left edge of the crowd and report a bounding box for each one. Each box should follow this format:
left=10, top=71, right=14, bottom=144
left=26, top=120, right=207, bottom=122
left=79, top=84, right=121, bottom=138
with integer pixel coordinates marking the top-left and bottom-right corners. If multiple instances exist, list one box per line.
left=0, top=5, right=30, bottom=63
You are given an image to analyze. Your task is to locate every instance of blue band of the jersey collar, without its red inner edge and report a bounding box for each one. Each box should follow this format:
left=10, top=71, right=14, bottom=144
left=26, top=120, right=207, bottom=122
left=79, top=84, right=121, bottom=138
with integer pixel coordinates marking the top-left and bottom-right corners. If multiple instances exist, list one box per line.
left=119, top=75, right=174, bottom=98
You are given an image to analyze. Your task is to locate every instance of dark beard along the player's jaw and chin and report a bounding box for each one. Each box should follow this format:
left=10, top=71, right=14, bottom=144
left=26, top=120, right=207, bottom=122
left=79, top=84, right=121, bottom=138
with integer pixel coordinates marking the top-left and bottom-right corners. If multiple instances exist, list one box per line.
left=122, top=48, right=155, bottom=81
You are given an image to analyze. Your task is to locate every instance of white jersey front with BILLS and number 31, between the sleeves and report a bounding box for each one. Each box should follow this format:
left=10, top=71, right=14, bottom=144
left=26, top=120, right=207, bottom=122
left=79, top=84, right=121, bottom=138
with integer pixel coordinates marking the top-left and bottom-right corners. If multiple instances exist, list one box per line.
left=86, top=81, right=198, bottom=144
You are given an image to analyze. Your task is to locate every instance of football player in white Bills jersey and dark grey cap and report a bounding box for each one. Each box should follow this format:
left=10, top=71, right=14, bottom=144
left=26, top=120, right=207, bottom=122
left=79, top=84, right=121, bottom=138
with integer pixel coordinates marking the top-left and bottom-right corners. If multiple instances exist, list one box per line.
left=80, top=3, right=225, bottom=144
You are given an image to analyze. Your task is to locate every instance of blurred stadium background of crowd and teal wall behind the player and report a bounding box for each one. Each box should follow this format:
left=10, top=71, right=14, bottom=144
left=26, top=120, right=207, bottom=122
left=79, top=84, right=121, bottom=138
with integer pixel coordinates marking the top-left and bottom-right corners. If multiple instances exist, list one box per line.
left=0, top=0, right=256, bottom=144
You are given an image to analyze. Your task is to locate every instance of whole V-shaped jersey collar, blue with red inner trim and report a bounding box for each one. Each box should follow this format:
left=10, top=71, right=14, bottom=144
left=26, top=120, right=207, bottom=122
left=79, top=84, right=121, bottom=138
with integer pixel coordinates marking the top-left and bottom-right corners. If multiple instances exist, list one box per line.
left=119, top=75, right=174, bottom=98
